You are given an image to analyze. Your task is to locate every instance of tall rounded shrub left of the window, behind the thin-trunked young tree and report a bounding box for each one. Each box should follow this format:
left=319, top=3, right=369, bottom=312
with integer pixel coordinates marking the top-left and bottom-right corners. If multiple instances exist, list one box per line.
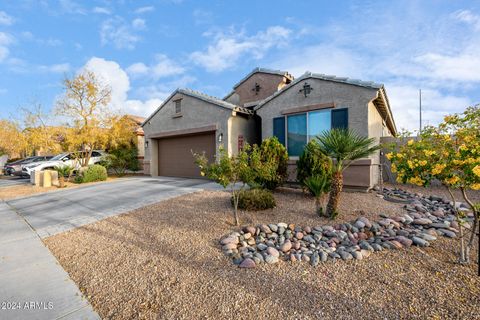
left=255, top=137, right=288, bottom=190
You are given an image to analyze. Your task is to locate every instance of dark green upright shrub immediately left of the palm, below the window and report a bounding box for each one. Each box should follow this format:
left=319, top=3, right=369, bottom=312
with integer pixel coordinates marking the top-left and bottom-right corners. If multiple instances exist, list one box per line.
left=297, top=139, right=332, bottom=190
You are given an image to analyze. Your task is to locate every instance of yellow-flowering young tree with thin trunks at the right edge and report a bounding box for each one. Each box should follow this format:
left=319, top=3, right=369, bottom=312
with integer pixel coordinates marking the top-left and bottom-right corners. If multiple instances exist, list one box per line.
left=386, top=105, right=480, bottom=263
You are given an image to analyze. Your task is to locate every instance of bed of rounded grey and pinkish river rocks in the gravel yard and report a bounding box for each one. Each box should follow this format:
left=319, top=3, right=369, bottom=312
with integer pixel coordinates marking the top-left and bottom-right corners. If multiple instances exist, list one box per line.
left=220, top=188, right=474, bottom=268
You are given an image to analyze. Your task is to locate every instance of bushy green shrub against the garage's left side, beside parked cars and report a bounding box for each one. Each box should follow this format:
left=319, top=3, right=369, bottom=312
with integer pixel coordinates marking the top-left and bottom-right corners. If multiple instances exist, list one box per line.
left=102, top=145, right=140, bottom=176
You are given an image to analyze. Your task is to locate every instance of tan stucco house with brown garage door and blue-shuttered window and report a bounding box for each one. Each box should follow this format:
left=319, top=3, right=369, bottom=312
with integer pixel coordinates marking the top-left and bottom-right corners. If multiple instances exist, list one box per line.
left=142, top=68, right=396, bottom=189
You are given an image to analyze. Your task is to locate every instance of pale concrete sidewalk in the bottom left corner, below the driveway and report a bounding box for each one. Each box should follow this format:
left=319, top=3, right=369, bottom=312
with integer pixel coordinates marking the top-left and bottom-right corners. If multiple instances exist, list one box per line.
left=0, top=202, right=99, bottom=320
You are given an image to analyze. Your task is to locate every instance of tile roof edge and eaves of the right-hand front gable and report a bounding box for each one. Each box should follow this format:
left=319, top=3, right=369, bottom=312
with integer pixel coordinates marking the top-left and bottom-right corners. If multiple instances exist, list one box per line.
left=255, top=71, right=397, bottom=135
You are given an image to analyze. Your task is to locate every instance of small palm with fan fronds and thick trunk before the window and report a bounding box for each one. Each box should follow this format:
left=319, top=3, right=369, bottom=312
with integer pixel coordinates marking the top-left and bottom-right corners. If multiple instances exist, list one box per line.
left=317, top=129, right=381, bottom=219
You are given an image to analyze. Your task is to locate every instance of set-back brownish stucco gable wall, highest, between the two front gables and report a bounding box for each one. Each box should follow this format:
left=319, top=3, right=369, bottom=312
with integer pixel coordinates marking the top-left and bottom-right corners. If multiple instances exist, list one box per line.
left=227, top=72, right=287, bottom=106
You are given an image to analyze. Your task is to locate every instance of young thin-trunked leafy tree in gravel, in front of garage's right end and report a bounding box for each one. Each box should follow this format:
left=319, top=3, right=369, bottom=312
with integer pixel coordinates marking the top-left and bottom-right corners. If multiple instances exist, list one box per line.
left=194, top=144, right=256, bottom=226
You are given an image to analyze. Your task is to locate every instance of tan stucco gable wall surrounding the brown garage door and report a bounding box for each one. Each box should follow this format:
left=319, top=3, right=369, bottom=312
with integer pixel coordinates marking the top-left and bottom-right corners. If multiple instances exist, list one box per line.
left=143, top=93, right=232, bottom=176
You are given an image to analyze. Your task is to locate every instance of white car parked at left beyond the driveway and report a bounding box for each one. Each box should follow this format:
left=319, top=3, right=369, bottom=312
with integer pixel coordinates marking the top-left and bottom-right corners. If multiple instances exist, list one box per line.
left=22, top=151, right=105, bottom=176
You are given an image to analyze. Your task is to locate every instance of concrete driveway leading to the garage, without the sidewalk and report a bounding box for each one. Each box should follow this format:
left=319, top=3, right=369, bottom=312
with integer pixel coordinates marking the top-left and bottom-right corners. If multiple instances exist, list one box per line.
left=6, top=177, right=218, bottom=238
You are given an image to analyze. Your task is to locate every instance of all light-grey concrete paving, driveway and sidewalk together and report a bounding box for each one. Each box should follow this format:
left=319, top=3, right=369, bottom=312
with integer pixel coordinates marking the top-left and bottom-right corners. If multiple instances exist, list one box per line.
left=0, top=177, right=221, bottom=320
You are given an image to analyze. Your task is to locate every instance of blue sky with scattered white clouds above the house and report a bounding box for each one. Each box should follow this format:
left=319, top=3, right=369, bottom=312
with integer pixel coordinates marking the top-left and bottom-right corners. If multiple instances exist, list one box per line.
left=0, top=0, right=480, bottom=129
